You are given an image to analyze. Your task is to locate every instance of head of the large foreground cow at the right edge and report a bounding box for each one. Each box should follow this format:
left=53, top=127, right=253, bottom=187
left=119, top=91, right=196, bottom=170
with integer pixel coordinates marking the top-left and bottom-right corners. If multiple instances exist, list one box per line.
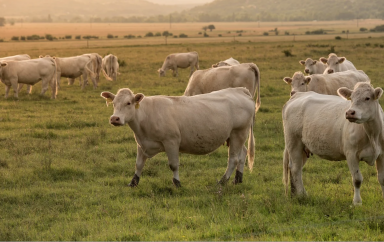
left=337, top=82, right=383, bottom=124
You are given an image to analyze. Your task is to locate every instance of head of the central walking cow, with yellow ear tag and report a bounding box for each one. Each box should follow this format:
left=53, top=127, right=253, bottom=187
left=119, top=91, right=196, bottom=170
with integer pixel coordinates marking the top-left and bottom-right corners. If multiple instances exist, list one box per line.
left=101, top=88, right=144, bottom=126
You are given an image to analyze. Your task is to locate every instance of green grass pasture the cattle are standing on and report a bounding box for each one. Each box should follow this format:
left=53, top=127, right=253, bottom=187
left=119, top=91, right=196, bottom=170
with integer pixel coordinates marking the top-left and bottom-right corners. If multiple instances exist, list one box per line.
left=0, top=22, right=384, bottom=241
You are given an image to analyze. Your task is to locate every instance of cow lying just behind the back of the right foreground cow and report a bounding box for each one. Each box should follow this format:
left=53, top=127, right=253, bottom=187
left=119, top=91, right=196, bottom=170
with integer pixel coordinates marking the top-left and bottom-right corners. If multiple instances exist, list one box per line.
left=283, top=70, right=370, bottom=96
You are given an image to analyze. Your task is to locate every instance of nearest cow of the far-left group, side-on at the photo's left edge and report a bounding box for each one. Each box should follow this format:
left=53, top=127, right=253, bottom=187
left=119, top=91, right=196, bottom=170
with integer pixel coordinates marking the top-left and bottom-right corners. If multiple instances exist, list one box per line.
left=0, top=57, right=57, bottom=99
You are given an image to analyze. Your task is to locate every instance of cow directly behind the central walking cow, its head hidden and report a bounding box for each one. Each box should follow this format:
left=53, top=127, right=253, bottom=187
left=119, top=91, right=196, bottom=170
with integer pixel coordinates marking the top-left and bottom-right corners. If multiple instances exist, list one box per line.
left=184, top=63, right=261, bottom=112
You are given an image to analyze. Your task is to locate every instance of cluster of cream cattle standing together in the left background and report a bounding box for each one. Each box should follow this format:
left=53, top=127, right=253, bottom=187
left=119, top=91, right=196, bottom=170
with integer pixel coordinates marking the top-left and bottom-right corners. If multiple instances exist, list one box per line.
left=0, top=53, right=119, bottom=99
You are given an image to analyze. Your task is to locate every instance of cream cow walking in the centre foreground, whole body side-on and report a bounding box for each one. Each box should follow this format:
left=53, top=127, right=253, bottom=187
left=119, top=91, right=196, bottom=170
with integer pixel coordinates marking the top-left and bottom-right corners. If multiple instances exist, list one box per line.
left=101, top=88, right=255, bottom=187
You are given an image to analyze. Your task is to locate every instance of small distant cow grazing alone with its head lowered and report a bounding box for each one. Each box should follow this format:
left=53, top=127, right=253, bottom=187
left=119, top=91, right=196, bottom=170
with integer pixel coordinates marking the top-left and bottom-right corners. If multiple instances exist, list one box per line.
left=157, top=51, right=199, bottom=76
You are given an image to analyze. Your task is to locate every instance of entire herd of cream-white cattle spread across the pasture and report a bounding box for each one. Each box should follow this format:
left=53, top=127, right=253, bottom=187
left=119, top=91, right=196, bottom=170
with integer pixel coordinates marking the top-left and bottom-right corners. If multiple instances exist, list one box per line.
left=0, top=52, right=384, bottom=205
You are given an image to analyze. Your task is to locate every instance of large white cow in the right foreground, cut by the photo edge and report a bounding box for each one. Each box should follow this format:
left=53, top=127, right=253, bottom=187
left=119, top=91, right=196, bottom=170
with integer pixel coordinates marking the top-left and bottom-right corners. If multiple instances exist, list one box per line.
left=283, top=82, right=384, bottom=205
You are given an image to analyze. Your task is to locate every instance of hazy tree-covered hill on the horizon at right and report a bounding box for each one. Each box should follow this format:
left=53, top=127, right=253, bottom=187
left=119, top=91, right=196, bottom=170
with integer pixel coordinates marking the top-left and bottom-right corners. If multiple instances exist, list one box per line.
left=185, top=0, right=384, bottom=21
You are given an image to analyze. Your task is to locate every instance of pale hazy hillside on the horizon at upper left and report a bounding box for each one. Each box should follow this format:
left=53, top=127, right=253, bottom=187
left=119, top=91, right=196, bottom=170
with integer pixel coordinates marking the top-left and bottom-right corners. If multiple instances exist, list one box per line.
left=0, top=0, right=197, bottom=21
